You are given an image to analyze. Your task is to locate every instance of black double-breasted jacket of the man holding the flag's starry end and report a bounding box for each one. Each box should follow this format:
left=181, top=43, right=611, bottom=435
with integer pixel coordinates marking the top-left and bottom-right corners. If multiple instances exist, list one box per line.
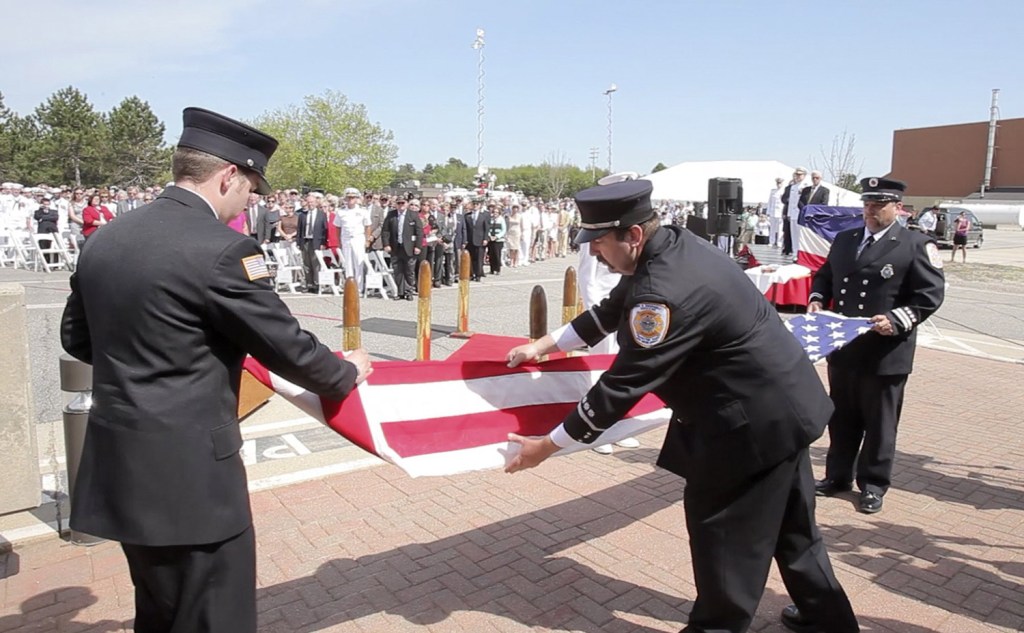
left=809, top=223, right=945, bottom=376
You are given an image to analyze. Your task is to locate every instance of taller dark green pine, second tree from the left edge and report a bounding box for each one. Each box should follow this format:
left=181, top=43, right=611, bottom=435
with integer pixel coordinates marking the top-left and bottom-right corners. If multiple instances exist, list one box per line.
left=36, top=86, right=109, bottom=186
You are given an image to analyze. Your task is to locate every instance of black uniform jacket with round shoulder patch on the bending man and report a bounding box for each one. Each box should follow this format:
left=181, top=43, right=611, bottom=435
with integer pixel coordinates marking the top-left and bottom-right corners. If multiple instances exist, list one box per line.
left=564, top=226, right=833, bottom=488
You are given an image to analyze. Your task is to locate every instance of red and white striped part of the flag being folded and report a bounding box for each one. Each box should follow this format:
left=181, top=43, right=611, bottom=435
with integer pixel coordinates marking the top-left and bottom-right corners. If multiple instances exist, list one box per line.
left=245, top=355, right=670, bottom=477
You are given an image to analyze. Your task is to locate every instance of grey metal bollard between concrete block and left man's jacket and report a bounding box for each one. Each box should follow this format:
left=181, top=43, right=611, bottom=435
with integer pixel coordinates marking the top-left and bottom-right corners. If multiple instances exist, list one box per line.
left=60, top=354, right=103, bottom=545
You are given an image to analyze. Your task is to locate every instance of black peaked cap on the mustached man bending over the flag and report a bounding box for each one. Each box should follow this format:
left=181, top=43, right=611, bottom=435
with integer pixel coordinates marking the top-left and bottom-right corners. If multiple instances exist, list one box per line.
left=575, top=180, right=654, bottom=244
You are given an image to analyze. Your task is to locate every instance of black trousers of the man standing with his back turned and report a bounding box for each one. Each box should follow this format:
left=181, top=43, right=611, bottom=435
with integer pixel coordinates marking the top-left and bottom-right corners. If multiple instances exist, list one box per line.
left=121, top=525, right=256, bottom=633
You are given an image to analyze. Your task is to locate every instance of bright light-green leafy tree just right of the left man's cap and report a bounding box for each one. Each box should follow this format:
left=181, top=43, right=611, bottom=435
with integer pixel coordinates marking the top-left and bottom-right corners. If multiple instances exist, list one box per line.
left=253, top=90, right=398, bottom=192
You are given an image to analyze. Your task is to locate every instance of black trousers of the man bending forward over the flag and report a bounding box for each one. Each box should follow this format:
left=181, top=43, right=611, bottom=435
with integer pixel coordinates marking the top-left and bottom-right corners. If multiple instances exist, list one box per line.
left=683, top=449, right=859, bottom=633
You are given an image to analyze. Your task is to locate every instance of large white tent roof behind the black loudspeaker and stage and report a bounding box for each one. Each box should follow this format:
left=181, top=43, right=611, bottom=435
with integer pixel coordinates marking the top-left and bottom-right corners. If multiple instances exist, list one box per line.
left=644, top=161, right=861, bottom=207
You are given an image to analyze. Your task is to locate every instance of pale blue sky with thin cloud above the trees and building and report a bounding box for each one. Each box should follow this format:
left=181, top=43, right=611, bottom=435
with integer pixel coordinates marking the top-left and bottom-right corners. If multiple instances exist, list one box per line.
left=0, top=0, right=1024, bottom=175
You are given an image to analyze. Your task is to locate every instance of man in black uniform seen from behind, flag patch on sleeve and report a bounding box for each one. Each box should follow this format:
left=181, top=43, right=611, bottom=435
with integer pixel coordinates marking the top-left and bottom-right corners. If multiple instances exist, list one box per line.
left=60, top=108, right=372, bottom=633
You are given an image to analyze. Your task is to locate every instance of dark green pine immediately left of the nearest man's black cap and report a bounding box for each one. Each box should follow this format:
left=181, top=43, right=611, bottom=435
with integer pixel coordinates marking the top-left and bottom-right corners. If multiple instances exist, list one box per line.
left=108, top=96, right=172, bottom=185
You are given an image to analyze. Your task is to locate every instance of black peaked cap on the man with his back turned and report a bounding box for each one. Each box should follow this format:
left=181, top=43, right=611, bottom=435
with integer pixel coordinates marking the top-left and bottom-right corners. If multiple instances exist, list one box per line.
left=178, top=108, right=278, bottom=196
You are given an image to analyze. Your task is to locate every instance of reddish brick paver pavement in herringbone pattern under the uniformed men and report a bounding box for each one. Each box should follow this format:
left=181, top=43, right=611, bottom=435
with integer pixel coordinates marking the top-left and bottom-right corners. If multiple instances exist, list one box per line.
left=0, top=349, right=1024, bottom=633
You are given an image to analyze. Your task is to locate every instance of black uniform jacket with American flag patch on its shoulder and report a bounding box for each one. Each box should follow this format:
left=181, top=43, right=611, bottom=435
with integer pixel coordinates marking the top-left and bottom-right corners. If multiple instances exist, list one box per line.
left=60, top=186, right=356, bottom=546
